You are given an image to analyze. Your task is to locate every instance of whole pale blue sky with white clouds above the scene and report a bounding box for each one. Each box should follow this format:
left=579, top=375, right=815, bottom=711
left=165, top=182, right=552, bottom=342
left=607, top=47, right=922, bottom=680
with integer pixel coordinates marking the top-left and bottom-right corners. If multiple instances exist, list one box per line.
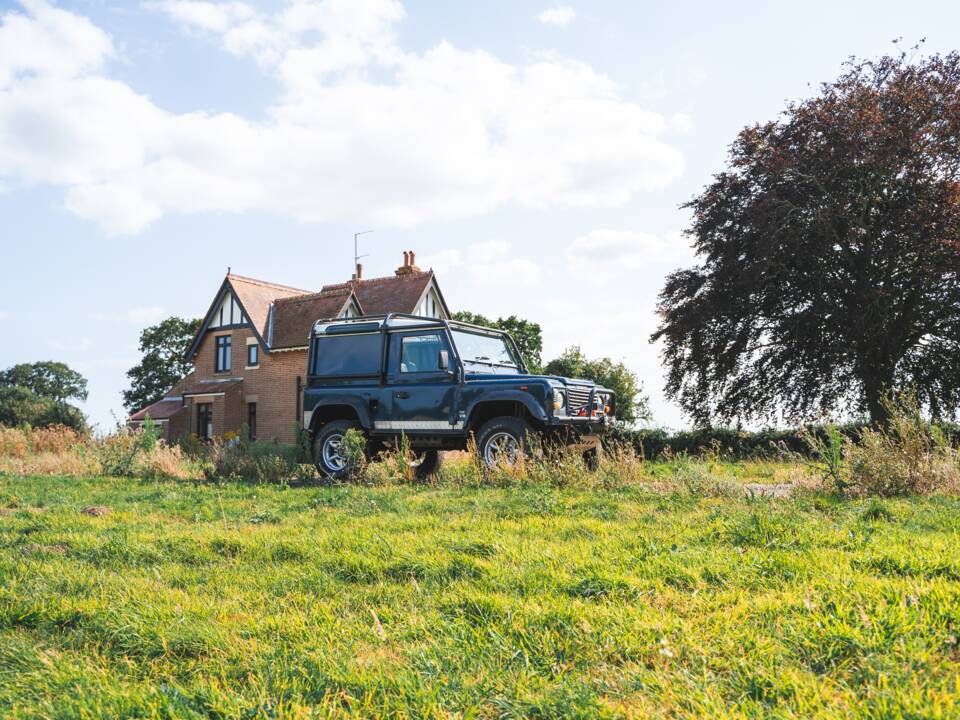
left=0, top=0, right=960, bottom=431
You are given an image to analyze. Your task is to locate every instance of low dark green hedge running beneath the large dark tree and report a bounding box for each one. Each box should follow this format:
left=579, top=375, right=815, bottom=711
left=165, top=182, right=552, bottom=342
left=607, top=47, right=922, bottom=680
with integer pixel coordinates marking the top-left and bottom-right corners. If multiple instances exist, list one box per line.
left=609, top=422, right=960, bottom=460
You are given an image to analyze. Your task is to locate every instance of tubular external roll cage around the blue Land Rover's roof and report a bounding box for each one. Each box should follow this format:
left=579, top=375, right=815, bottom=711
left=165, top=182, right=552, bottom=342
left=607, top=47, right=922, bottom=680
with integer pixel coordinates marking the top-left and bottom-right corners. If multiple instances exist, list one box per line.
left=308, top=313, right=529, bottom=380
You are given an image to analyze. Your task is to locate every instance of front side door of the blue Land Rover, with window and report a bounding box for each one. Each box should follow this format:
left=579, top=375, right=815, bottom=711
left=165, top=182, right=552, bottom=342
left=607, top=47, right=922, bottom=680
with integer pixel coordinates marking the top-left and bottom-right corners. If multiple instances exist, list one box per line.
left=377, top=329, right=458, bottom=435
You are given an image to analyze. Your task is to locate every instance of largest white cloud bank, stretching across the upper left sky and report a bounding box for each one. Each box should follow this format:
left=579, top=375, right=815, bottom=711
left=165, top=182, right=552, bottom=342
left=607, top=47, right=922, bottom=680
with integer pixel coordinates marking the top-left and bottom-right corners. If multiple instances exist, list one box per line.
left=0, top=0, right=683, bottom=234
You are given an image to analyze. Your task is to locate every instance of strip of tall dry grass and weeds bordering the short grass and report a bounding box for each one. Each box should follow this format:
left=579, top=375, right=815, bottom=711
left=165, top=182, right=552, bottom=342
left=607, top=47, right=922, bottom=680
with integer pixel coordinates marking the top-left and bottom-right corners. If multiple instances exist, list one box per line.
left=0, top=398, right=960, bottom=497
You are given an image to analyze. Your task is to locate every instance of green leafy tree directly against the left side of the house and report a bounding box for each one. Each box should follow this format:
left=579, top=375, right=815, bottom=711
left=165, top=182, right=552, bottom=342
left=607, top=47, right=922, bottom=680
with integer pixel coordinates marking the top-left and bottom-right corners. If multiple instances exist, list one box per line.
left=123, top=317, right=200, bottom=412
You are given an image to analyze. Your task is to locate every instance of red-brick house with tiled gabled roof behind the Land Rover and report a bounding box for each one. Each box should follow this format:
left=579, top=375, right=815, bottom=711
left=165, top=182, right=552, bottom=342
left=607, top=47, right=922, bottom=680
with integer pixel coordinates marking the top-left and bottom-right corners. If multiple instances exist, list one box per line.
left=129, top=252, right=450, bottom=443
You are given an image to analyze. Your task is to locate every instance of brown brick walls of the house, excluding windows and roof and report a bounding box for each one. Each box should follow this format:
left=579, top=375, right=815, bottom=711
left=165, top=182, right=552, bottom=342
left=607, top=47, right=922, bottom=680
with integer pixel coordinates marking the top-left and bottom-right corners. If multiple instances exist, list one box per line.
left=187, top=328, right=307, bottom=443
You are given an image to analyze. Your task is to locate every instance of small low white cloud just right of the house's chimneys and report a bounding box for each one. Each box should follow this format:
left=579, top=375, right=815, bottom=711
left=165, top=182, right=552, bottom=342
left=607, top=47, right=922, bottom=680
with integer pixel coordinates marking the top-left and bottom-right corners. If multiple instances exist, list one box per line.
left=423, top=240, right=541, bottom=288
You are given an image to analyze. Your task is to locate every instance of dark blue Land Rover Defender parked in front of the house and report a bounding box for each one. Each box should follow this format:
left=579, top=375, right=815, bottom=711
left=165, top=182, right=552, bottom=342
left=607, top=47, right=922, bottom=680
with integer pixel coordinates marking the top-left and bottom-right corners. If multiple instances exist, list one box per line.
left=303, top=314, right=615, bottom=478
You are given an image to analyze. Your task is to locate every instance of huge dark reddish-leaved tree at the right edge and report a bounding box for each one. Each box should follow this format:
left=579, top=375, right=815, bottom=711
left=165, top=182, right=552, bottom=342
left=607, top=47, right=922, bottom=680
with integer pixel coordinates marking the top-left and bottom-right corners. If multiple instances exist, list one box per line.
left=652, top=53, right=960, bottom=424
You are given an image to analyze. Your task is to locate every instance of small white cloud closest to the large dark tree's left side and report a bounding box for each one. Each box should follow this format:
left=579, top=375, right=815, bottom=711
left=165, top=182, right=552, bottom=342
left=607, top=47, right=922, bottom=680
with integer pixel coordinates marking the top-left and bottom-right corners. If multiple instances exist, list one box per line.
left=564, top=229, right=694, bottom=277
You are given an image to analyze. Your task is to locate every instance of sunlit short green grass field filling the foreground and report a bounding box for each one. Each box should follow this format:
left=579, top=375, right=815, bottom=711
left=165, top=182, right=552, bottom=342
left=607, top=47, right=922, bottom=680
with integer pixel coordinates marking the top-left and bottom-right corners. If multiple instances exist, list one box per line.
left=0, top=473, right=960, bottom=718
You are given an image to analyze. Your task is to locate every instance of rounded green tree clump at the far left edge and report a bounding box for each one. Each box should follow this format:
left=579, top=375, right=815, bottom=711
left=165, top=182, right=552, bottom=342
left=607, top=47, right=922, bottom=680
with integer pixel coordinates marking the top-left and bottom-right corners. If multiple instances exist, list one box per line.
left=0, top=361, right=87, bottom=431
